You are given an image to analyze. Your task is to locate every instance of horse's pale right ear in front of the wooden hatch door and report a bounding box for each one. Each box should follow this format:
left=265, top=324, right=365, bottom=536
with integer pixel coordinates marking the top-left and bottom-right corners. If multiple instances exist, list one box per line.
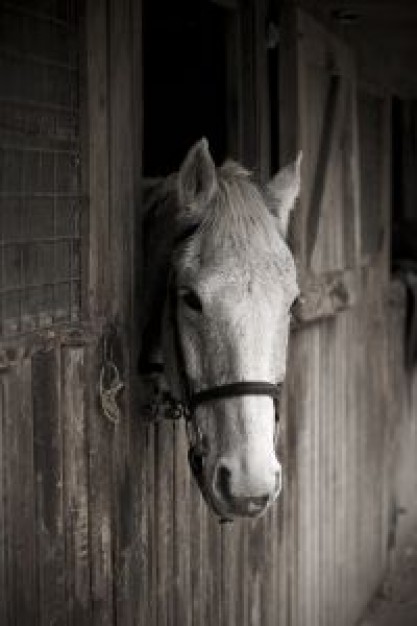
left=267, top=150, right=303, bottom=239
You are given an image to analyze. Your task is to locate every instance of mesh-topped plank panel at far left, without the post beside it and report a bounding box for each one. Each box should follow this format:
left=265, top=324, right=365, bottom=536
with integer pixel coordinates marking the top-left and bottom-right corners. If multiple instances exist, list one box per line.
left=0, top=1, right=89, bottom=625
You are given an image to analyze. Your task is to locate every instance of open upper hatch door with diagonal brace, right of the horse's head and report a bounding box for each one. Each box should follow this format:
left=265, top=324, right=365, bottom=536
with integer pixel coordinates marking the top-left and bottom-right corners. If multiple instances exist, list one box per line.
left=281, top=11, right=360, bottom=321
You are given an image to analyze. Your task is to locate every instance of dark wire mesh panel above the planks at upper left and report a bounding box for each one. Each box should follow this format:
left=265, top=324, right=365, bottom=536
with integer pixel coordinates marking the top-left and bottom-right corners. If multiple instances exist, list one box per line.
left=0, top=0, right=81, bottom=336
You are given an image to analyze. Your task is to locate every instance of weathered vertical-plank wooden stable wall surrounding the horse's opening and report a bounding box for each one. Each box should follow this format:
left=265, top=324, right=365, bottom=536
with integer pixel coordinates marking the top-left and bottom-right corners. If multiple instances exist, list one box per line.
left=0, top=0, right=417, bottom=626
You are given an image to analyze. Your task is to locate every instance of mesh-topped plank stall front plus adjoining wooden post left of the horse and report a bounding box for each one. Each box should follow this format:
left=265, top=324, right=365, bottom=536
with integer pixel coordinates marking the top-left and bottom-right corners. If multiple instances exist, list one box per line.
left=0, top=0, right=142, bottom=626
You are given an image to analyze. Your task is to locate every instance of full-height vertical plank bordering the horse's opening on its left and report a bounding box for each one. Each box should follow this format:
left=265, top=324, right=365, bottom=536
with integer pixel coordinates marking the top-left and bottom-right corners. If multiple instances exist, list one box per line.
left=107, top=0, right=145, bottom=626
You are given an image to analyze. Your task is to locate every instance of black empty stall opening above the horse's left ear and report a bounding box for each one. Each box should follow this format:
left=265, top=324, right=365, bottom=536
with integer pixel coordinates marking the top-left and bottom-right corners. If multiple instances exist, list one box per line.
left=143, top=0, right=228, bottom=177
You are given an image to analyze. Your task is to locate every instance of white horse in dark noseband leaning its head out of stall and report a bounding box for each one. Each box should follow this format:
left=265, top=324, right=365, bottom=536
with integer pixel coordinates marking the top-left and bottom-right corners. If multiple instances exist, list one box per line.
left=140, top=139, right=301, bottom=519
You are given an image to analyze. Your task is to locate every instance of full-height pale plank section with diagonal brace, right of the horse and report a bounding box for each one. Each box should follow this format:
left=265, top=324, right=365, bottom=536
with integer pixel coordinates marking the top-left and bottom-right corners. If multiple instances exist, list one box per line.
left=281, top=10, right=393, bottom=626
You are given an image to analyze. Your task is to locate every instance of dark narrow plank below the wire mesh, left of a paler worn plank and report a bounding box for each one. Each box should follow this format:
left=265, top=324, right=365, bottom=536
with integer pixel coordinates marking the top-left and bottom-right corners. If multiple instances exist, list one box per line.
left=32, top=349, right=67, bottom=626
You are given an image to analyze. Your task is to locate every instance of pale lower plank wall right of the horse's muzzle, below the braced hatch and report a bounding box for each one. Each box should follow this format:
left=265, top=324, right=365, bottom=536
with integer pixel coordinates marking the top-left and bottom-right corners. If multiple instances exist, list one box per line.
left=287, top=272, right=391, bottom=626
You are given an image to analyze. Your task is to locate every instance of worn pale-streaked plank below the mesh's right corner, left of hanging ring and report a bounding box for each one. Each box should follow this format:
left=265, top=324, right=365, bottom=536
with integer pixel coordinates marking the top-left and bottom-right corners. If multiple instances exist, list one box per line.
left=61, top=346, right=92, bottom=626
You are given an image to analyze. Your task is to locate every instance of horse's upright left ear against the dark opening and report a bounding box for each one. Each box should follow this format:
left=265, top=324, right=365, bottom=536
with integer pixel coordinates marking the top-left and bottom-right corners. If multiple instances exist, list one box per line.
left=178, top=137, right=217, bottom=208
